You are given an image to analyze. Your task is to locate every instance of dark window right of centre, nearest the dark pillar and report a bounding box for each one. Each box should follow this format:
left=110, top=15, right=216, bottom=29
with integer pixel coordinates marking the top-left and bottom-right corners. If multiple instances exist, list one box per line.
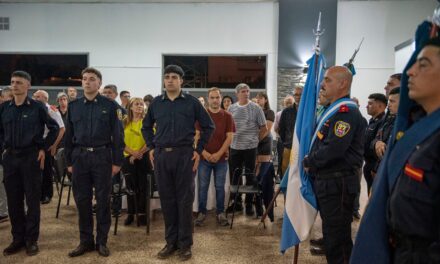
left=163, top=55, right=267, bottom=89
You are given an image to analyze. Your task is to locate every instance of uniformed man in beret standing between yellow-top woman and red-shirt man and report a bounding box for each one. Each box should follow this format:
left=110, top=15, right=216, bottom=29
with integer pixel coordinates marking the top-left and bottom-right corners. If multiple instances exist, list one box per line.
left=142, top=65, right=214, bottom=261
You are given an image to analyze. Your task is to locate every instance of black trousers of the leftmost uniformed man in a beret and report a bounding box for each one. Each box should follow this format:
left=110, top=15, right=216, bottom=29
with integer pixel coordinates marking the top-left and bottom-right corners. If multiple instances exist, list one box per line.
left=3, top=149, right=42, bottom=242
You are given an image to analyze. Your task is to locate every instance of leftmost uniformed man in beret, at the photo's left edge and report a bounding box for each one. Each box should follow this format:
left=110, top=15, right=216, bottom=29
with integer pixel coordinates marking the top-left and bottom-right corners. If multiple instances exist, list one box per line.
left=0, top=71, right=58, bottom=256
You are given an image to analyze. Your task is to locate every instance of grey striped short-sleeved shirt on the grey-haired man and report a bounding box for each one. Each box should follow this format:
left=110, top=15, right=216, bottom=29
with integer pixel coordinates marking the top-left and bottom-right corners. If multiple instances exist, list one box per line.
left=228, top=102, right=266, bottom=150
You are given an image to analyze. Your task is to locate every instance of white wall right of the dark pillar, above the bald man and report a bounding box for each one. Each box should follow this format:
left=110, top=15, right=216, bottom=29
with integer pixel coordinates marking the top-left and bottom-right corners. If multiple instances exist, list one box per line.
left=336, top=0, right=437, bottom=115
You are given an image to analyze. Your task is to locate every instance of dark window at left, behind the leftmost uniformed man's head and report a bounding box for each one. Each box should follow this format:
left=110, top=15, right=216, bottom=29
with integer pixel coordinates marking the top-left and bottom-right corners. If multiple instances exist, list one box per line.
left=0, top=53, right=88, bottom=87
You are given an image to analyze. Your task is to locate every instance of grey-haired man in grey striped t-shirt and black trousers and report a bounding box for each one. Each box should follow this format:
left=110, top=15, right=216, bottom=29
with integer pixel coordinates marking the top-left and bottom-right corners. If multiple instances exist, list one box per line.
left=228, top=83, right=267, bottom=215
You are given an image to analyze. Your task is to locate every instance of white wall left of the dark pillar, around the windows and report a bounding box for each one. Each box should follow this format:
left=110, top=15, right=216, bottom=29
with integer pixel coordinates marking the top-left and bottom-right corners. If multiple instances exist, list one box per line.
left=0, top=2, right=278, bottom=105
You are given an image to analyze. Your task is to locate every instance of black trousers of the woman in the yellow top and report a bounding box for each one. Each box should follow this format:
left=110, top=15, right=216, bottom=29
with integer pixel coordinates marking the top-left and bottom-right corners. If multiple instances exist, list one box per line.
left=122, top=157, right=151, bottom=214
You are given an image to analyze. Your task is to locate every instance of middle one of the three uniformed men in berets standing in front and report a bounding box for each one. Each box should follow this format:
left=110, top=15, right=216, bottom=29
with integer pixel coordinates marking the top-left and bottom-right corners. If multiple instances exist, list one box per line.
left=65, top=68, right=124, bottom=257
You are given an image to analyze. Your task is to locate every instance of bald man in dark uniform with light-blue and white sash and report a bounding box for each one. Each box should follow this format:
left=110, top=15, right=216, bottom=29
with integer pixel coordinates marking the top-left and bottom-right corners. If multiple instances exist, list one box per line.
left=303, top=66, right=366, bottom=264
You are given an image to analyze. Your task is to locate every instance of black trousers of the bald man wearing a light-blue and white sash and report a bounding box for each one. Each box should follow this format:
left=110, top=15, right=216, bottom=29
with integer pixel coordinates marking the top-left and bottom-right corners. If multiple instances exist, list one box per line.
left=313, top=171, right=359, bottom=264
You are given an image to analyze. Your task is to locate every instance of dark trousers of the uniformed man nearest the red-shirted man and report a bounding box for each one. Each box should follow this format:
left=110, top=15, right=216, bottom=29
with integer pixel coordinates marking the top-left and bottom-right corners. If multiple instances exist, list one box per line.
left=154, top=146, right=195, bottom=248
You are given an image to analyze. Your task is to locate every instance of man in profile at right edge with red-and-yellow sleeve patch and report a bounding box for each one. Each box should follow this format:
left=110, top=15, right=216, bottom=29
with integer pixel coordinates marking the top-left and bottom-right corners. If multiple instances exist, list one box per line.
left=387, top=38, right=440, bottom=263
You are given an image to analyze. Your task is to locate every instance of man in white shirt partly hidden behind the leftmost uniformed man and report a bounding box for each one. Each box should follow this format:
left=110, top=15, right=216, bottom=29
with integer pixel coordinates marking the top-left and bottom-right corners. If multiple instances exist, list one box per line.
left=33, top=90, right=65, bottom=204
